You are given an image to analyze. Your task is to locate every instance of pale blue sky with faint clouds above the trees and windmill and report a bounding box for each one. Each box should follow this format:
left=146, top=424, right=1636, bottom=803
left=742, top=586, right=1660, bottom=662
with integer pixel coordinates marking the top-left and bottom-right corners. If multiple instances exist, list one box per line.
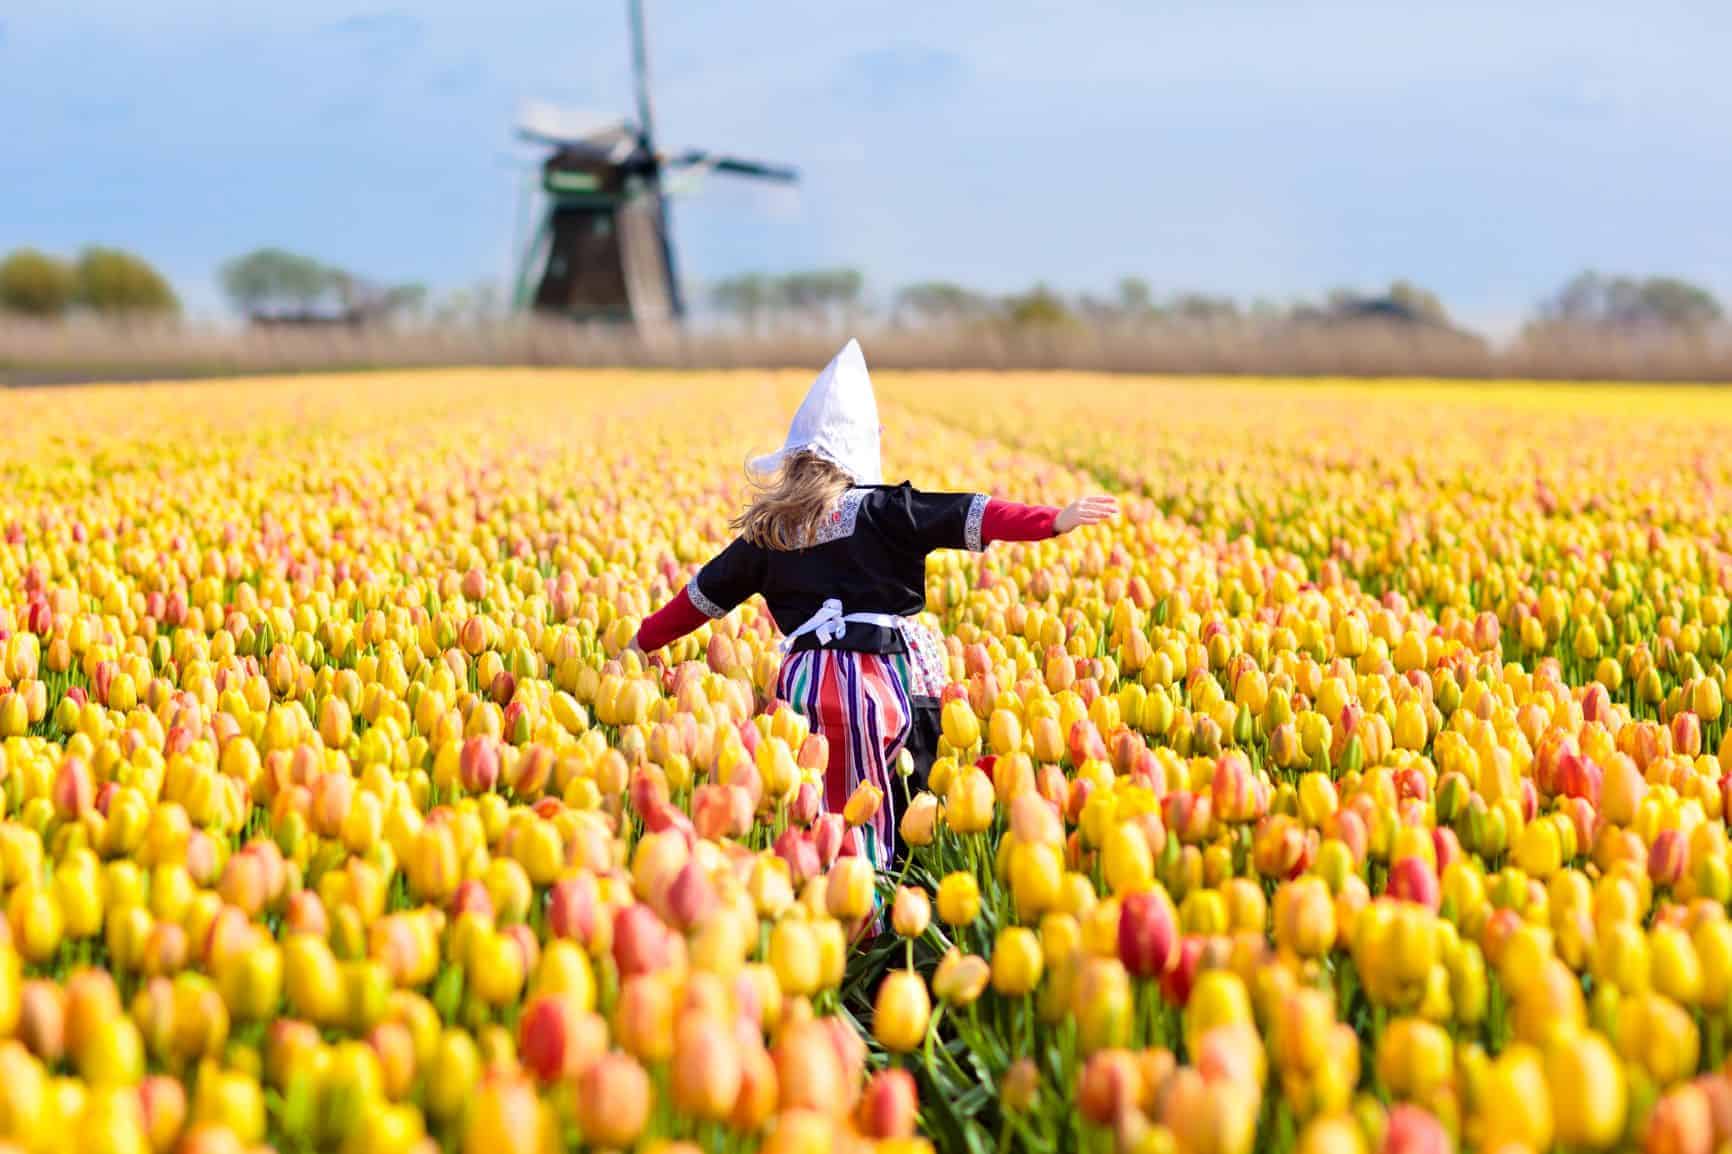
left=0, top=0, right=1732, bottom=331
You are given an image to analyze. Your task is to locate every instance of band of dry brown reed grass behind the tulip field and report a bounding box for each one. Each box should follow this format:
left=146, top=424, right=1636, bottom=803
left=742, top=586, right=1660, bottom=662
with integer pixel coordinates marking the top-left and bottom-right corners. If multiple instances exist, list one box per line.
left=0, top=319, right=1732, bottom=385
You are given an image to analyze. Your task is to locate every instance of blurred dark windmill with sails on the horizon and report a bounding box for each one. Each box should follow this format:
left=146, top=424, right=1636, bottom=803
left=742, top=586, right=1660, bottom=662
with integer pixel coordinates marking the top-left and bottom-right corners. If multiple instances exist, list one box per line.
left=516, top=0, right=797, bottom=327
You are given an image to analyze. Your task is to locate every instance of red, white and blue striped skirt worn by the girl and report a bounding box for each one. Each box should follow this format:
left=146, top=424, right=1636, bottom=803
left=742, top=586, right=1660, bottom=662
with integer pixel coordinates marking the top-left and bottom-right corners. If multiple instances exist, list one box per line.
left=776, top=650, right=914, bottom=870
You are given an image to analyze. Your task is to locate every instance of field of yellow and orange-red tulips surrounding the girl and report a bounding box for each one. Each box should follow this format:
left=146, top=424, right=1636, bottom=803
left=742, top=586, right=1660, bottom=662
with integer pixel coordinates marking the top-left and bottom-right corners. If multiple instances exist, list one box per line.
left=0, top=369, right=1732, bottom=1154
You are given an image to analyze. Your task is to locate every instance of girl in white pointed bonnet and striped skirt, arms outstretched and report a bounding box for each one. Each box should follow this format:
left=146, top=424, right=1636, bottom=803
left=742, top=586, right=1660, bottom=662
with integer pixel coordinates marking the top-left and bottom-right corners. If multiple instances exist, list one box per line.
left=634, top=341, right=1117, bottom=870
